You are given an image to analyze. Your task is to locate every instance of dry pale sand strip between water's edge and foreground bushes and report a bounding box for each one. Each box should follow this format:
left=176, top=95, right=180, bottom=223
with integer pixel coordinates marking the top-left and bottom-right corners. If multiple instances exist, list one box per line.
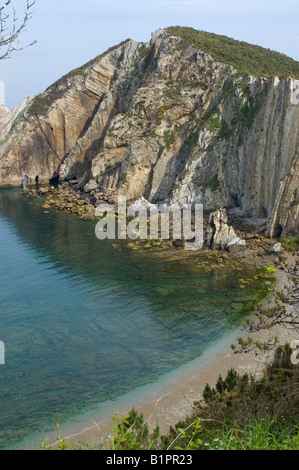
left=47, top=256, right=299, bottom=446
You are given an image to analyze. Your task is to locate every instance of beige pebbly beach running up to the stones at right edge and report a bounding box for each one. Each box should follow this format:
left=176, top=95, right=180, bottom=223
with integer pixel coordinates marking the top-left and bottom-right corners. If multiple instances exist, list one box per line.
left=50, top=254, right=299, bottom=449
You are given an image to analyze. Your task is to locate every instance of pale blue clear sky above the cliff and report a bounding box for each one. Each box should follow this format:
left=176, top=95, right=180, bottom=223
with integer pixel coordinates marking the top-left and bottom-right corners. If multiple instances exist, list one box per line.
left=0, top=0, right=299, bottom=108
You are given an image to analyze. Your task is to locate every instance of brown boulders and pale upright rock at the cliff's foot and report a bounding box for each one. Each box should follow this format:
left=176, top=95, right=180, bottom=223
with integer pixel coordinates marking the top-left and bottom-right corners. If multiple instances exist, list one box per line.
left=22, top=181, right=299, bottom=280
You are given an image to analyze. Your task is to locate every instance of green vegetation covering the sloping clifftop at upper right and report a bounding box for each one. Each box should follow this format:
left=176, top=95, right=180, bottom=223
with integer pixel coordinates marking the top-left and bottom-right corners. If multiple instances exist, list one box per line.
left=167, top=26, right=299, bottom=79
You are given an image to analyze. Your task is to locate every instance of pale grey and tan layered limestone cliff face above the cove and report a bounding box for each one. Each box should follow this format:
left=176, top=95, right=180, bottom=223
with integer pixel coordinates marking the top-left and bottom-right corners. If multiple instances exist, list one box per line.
left=0, top=30, right=299, bottom=236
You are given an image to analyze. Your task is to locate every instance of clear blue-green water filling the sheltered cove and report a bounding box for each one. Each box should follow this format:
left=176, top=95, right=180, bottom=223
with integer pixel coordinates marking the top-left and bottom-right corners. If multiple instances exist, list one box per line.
left=0, top=190, right=253, bottom=448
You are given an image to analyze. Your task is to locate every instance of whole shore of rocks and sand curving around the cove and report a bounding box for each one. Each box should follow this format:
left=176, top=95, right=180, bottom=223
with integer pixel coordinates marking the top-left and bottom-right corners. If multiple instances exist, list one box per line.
left=19, top=183, right=299, bottom=445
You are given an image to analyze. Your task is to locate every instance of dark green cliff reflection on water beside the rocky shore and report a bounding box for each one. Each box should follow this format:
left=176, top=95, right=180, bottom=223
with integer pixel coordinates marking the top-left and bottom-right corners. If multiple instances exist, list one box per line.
left=0, top=190, right=258, bottom=316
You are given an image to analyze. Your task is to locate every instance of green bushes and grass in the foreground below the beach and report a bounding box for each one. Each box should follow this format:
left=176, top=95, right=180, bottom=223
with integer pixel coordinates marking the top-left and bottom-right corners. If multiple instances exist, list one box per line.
left=42, top=344, right=299, bottom=450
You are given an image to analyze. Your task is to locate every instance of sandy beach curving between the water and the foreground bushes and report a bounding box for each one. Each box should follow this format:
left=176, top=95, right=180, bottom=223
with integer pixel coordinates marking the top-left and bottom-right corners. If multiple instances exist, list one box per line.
left=49, top=248, right=299, bottom=448
